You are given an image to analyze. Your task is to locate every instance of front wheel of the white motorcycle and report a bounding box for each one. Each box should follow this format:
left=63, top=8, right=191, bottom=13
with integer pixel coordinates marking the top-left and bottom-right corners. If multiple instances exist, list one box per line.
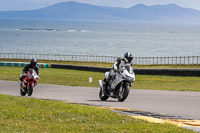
left=117, top=85, right=130, bottom=102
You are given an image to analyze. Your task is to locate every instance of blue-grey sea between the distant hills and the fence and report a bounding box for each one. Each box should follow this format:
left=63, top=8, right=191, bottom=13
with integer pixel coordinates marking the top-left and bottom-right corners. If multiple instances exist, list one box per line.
left=0, top=19, right=200, bottom=57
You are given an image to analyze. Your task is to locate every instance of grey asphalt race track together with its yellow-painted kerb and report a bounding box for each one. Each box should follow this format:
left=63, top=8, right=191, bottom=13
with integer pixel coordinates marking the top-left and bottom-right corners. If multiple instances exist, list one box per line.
left=0, top=80, right=200, bottom=132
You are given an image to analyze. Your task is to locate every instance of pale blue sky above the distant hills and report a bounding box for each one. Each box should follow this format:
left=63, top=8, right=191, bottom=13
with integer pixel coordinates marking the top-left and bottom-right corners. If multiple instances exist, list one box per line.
left=0, top=0, right=200, bottom=11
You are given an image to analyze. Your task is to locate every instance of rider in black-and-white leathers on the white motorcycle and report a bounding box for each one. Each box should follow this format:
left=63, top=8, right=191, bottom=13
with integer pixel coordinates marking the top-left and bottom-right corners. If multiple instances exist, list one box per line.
left=103, top=52, right=133, bottom=89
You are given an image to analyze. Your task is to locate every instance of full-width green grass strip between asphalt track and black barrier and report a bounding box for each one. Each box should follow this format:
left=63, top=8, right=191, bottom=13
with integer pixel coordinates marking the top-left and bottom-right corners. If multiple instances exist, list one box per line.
left=0, top=67, right=200, bottom=92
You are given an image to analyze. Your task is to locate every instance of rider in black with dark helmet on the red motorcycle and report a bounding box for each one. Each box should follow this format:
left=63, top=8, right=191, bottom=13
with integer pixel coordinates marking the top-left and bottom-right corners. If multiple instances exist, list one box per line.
left=20, top=58, right=40, bottom=85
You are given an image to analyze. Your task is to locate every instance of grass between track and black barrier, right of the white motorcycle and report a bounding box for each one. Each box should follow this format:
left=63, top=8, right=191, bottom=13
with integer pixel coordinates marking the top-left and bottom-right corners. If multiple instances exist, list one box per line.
left=133, top=75, right=200, bottom=92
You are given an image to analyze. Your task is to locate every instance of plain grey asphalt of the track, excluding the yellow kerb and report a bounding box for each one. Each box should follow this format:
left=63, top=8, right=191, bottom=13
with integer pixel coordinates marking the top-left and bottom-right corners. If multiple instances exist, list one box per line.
left=0, top=80, right=200, bottom=120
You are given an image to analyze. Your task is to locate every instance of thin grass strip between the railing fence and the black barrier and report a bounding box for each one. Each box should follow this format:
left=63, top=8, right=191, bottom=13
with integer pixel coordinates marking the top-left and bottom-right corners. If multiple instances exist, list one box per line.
left=0, top=59, right=200, bottom=69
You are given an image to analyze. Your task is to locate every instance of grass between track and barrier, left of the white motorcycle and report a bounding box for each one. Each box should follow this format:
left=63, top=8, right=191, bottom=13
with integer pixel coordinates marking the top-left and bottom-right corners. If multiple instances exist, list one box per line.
left=0, top=67, right=104, bottom=87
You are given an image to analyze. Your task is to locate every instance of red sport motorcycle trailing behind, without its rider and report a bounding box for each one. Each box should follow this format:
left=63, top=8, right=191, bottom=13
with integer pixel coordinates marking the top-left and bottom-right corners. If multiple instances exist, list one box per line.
left=20, top=69, right=39, bottom=96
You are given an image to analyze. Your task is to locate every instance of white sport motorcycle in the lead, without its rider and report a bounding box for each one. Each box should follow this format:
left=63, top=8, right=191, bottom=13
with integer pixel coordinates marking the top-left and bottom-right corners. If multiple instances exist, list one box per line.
left=98, top=64, right=135, bottom=102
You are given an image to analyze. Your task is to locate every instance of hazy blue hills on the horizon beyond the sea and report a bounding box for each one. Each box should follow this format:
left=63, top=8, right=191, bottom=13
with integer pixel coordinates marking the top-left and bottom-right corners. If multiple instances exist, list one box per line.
left=0, top=2, right=200, bottom=23
